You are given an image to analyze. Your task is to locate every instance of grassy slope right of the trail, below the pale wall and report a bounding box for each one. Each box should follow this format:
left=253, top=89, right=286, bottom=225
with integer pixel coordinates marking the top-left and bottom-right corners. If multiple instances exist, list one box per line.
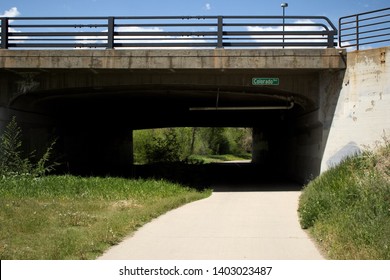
left=298, top=139, right=390, bottom=260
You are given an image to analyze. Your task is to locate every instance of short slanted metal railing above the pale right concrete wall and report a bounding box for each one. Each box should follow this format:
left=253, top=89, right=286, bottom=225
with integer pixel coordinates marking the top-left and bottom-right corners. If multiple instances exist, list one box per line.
left=339, top=8, right=390, bottom=50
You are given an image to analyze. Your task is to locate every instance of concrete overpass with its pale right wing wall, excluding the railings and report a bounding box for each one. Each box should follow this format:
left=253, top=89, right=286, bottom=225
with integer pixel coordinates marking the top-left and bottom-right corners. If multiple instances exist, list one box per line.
left=0, top=12, right=390, bottom=184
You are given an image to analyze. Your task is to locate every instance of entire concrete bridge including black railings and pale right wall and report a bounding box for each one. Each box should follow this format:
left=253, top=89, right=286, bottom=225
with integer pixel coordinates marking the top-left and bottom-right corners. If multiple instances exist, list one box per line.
left=0, top=11, right=390, bottom=182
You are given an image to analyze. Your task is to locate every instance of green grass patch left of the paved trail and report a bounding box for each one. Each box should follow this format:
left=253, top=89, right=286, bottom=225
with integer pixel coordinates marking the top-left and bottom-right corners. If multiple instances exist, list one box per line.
left=0, top=176, right=211, bottom=260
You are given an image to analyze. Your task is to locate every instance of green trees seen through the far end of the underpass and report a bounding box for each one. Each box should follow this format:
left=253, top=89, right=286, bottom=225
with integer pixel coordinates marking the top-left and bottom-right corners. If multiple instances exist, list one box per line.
left=133, top=127, right=252, bottom=164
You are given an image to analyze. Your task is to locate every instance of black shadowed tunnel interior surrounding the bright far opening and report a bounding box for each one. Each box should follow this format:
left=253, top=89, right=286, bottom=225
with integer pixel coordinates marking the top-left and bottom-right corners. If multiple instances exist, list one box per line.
left=8, top=81, right=312, bottom=184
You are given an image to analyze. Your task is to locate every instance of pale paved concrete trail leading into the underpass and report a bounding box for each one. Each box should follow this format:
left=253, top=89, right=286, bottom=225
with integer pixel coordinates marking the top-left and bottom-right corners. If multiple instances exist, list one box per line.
left=99, top=185, right=323, bottom=260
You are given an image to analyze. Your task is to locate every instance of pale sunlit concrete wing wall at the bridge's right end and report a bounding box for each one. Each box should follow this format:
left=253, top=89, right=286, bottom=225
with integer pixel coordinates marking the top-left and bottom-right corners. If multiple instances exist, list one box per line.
left=321, top=47, right=390, bottom=172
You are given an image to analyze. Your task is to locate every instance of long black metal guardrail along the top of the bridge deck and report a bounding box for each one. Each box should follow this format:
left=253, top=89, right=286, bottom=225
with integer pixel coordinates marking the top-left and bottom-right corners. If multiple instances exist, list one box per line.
left=0, top=16, right=337, bottom=49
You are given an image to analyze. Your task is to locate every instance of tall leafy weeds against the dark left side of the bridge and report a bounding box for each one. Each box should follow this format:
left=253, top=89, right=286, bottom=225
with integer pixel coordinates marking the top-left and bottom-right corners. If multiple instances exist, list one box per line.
left=0, top=117, right=58, bottom=177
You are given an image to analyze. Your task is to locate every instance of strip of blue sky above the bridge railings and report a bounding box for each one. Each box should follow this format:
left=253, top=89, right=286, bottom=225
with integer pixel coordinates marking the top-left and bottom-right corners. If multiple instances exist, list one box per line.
left=0, top=0, right=390, bottom=24
